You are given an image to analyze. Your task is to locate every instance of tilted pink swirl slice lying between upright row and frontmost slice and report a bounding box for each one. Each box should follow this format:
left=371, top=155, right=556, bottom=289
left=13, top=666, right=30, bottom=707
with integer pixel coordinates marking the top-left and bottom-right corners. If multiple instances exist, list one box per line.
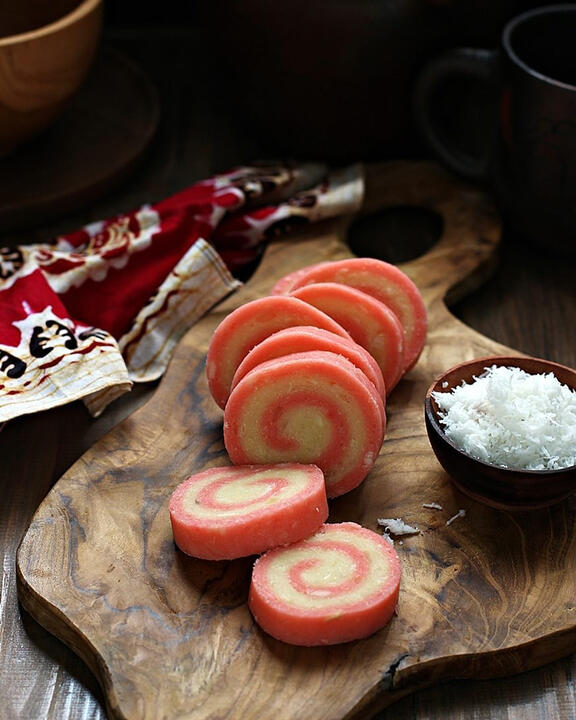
left=170, top=463, right=328, bottom=560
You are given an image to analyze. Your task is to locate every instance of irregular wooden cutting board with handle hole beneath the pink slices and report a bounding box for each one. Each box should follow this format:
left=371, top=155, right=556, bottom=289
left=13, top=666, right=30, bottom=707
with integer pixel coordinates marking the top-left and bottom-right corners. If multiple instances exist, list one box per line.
left=17, top=163, right=576, bottom=720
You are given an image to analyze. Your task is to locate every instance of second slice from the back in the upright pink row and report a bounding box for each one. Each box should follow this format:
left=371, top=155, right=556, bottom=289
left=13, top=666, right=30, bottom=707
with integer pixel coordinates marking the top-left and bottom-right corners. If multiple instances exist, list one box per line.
left=291, top=283, right=404, bottom=392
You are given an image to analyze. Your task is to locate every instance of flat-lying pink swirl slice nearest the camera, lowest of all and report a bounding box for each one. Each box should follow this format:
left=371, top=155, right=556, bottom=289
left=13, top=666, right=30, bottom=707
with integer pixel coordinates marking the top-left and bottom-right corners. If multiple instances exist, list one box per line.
left=248, top=523, right=401, bottom=645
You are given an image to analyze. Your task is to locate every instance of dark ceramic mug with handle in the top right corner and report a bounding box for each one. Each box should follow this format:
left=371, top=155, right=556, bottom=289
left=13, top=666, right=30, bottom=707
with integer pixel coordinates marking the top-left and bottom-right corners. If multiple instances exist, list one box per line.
left=415, top=4, right=576, bottom=253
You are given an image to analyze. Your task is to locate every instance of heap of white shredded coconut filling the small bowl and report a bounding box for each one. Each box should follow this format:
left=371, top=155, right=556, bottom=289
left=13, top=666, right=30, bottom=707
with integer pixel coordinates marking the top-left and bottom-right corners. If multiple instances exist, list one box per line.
left=433, top=365, right=576, bottom=470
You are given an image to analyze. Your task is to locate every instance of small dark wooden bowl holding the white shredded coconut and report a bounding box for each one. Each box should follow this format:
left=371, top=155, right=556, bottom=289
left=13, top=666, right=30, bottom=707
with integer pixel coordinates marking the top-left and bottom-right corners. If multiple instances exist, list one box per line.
left=424, top=357, right=576, bottom=510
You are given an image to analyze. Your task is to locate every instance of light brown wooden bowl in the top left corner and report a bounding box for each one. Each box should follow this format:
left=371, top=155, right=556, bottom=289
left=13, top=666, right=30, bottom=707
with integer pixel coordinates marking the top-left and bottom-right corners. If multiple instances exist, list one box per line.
left=0, top=0, right=102, bottom=156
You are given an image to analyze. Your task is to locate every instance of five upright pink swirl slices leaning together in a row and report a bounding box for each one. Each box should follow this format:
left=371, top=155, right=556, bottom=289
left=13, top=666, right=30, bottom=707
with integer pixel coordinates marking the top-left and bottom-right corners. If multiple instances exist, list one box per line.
left=206, top=258, right=427, bottom=497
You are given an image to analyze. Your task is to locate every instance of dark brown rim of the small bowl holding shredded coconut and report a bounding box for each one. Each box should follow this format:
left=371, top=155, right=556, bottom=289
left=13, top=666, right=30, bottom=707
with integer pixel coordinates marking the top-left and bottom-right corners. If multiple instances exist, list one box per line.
left=424, top=355, right=576, bottom=480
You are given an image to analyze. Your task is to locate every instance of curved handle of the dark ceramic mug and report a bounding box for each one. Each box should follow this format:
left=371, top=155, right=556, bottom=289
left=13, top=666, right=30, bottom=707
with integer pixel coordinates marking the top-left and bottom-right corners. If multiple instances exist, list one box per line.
left=414, top=48, right=499, bottom=180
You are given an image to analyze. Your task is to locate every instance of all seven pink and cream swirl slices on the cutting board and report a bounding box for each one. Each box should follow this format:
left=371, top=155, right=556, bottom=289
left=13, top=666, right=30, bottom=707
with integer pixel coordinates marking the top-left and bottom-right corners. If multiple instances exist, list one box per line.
left=170, top=258, right=427, bottom=645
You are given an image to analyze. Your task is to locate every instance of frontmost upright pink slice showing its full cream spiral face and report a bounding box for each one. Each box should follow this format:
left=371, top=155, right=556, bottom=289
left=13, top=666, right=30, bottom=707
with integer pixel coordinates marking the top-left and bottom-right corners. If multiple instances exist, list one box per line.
left=224, top=351, right=386, bottom=497
